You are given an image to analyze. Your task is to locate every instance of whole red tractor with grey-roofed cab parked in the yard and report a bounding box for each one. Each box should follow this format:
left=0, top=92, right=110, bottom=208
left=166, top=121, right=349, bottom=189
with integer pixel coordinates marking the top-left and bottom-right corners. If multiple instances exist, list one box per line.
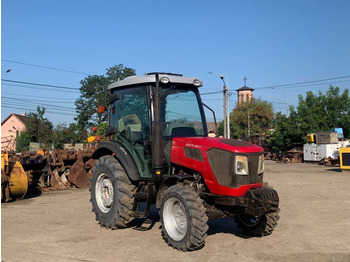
left=90, top=73, right=279, bottom=251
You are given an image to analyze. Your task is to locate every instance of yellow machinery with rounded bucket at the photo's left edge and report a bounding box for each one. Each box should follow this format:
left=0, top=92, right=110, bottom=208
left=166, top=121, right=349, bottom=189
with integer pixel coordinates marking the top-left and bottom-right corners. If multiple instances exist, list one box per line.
left=1, top=153, right=28, bottom=202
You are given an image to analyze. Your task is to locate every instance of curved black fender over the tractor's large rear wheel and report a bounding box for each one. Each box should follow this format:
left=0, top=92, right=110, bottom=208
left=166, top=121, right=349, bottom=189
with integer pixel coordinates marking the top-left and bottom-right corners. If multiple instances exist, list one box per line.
left=92, top=141, right=140, bottom=181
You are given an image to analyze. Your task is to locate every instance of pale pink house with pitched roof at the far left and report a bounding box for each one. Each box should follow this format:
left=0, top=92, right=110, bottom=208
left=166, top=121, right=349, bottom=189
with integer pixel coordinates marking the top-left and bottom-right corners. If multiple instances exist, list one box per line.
left=1, top=113, right=30, bottom=152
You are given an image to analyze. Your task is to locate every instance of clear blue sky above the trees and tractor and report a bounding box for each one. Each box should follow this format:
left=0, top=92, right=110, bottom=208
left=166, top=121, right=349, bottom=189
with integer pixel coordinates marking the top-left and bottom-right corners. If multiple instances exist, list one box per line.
left=1, top=0, right=350, bottom=125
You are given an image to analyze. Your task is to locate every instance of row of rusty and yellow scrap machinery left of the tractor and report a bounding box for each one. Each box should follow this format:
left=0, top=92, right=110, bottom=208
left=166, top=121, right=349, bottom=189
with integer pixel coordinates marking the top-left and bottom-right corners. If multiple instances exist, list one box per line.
left=1, top=149, right=95, bottom=202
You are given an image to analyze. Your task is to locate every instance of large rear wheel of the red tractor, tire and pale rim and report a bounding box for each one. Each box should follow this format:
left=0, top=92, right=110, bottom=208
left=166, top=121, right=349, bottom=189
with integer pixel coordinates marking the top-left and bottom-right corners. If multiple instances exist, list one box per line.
left=90, top=156, right=136, bottom=229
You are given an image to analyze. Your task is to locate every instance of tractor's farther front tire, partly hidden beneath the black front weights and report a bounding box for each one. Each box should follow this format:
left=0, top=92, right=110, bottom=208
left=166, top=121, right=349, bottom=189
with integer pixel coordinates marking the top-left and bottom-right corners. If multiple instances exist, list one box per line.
left=235, top=212, right=280, bottom=237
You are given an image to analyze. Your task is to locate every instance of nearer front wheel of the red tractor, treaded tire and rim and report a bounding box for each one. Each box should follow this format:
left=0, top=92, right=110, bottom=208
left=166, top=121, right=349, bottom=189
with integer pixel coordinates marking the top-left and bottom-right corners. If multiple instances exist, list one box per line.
left=160, top=184, right=209, bottom=251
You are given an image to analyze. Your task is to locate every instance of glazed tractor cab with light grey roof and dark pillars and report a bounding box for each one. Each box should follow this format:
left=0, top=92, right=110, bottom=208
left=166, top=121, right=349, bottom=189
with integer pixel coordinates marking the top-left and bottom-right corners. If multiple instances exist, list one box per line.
left=107, top=73, right=207, bottom=178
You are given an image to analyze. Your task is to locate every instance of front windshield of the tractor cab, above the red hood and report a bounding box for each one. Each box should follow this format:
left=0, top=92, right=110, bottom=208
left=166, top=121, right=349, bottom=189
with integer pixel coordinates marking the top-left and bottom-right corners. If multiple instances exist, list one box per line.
left=160, top=86, right=205, bottom=137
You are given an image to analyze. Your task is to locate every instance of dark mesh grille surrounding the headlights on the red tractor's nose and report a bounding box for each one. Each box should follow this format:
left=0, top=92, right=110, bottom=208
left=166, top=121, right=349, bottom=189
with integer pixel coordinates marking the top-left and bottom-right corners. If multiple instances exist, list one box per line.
left=207, top=148, right=263, bottom=188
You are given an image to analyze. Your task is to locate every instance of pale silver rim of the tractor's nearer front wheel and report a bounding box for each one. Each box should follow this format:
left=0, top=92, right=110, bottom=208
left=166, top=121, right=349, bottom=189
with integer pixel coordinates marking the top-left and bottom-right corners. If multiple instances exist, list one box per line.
left=163, top=197, right=188, bottom=241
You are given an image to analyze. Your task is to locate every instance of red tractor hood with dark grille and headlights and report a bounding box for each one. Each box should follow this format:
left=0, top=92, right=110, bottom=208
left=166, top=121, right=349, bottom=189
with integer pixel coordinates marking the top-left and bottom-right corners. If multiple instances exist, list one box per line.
left=170, top=137, right=264, bottom=196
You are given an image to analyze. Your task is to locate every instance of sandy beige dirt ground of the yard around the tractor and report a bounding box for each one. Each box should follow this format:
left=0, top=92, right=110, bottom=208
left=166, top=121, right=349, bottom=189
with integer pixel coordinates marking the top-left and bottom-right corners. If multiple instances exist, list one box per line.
left=1, top=161, right=350, bottom=262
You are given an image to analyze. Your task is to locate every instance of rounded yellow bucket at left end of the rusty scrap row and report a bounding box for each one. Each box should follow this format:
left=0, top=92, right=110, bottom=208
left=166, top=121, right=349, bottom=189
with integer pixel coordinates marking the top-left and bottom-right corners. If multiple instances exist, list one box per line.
left=9, top=161, right=28, bottom=198
